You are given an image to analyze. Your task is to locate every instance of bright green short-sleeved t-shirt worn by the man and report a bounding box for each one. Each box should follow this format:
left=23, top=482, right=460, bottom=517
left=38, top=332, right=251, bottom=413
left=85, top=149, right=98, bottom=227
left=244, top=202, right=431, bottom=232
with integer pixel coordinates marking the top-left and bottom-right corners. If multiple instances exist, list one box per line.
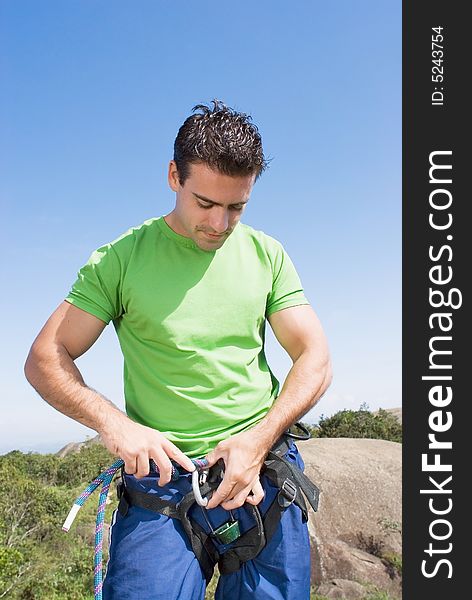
left=66, top=217, right=308, bottom=457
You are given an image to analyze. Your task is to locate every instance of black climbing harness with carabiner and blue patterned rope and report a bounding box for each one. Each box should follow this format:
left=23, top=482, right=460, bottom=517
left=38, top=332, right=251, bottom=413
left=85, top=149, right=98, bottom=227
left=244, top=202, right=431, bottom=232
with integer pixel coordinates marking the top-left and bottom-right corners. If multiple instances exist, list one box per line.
left=63, top=423, right=319, bottom=600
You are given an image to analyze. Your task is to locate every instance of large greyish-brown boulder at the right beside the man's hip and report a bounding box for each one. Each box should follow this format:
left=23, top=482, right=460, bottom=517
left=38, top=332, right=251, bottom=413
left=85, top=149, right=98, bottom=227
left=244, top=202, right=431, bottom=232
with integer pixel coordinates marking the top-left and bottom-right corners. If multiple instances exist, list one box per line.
left=297, top=438, right=402, bottom=599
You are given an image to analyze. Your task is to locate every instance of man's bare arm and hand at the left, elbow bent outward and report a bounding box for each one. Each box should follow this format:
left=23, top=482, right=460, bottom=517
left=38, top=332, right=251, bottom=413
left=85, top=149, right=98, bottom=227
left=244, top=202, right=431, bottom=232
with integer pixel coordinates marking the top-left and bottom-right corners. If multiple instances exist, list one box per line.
left=25, top=302, right=194, bottom=486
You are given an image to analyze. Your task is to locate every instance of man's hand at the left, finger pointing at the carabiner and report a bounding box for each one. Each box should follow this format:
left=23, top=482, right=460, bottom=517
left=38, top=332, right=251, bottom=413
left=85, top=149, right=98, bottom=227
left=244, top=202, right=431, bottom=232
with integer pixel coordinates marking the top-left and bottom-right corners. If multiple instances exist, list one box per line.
left=100, top=413, right=195, bottom=487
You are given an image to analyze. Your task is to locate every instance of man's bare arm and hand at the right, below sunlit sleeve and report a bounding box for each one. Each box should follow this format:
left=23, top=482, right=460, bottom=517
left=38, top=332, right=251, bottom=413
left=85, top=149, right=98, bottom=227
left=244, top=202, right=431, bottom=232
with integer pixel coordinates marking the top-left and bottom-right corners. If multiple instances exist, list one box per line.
left=207, top=305, right=331, bottom=510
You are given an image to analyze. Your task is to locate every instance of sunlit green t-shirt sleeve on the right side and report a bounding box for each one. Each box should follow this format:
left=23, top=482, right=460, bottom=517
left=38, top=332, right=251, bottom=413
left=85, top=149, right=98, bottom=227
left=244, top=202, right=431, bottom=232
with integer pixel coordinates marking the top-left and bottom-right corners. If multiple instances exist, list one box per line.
left=266, top=244, right=309, bottom=317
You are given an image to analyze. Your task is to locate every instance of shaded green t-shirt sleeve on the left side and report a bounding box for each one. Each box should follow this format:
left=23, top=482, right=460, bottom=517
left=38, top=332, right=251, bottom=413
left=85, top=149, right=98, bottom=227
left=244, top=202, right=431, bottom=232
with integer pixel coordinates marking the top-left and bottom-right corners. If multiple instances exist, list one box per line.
left=66, top=244, right=123, bottom=324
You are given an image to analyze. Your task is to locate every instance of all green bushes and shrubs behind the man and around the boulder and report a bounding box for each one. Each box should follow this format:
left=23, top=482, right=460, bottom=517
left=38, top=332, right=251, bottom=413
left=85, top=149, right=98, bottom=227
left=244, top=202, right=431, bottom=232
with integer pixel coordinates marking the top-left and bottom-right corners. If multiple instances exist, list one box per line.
left=0, top=406, right=401, bottom=600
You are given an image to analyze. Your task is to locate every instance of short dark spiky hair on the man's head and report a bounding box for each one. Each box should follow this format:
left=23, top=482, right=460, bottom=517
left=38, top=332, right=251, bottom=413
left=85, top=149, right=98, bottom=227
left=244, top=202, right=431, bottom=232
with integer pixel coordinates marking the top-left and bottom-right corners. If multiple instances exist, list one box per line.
left=174, top=100, right=267, bottom=185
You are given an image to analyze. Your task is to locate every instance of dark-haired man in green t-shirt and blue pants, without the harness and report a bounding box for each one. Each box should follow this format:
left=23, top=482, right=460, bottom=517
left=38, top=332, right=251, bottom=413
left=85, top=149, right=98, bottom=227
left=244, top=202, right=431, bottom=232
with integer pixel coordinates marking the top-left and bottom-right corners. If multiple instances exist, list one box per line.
left=25, top=101, right=331, bottom=600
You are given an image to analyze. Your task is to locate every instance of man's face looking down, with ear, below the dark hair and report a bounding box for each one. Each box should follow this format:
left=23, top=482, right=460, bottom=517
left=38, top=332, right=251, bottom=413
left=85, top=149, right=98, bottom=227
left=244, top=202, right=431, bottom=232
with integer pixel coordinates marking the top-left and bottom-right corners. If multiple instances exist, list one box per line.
left=166, top=160, right=255, bottom=251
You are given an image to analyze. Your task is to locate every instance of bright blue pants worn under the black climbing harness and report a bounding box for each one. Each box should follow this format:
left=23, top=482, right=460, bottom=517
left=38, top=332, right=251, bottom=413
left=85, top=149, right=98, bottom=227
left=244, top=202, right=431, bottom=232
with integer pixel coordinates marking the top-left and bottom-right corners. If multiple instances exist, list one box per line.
left=103, top=442, right=310, bottom=600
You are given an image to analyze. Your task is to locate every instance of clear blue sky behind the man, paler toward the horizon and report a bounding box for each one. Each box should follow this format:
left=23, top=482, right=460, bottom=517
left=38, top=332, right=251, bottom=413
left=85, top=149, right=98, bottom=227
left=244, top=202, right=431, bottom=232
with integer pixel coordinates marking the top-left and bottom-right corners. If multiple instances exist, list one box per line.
left=0, top=0, right=401, bottom=452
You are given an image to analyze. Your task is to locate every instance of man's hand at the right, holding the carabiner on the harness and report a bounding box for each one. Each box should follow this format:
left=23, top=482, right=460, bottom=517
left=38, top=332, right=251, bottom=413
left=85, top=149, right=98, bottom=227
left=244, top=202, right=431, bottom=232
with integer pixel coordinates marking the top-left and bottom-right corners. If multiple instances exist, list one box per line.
left=206, top=430, right=270, bottom=510
